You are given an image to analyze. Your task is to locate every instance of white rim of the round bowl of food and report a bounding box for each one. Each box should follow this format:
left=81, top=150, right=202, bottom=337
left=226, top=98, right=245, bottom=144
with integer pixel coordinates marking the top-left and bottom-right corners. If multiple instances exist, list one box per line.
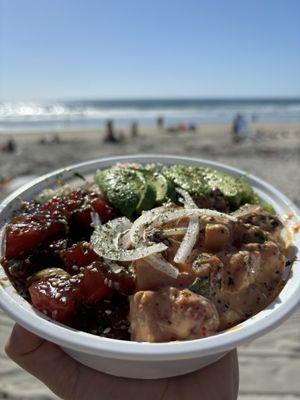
left=0, top=154, right=300, bottom=361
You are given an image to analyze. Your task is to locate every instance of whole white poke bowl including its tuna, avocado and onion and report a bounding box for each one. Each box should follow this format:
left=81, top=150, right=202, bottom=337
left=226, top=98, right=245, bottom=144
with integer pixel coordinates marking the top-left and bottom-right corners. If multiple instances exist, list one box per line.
left=0, top=155, right=300, bottom=379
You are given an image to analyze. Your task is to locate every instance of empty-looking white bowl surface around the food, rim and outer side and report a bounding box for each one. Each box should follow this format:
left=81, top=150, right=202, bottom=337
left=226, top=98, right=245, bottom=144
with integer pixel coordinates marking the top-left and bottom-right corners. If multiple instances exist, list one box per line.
left=0, top=155, right=300, bottom=379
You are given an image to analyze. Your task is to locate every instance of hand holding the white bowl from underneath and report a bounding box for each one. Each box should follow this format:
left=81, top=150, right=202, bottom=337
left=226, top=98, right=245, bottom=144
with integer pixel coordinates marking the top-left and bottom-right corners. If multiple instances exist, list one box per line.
left=6, top=325, right=238, bottom=400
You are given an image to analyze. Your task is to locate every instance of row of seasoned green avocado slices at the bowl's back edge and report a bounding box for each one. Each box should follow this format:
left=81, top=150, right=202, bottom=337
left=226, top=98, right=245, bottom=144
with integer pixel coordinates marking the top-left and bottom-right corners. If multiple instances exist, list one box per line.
left=95, top=165, right=259, bottom=218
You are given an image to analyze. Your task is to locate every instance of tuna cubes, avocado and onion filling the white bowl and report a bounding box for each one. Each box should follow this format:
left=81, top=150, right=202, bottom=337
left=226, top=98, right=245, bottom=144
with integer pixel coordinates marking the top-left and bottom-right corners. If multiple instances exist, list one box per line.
left=1, top=164, right=288, bottom=342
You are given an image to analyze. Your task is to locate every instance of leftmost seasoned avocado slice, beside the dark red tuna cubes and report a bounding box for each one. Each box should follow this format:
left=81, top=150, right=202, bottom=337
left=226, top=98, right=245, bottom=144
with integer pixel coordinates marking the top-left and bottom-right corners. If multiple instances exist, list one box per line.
left=95, top=167, right=155, bottom=218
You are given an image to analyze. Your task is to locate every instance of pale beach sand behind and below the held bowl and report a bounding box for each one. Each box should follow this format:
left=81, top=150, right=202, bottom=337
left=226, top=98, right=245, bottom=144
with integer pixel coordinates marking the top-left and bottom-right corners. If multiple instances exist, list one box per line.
left=0, top=124, right=300, bottom=400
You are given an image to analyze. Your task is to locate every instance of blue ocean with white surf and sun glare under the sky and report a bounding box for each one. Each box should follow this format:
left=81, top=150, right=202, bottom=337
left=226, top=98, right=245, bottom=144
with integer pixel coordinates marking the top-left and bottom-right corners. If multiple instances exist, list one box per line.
left=0, top=98, right=300, bottom=133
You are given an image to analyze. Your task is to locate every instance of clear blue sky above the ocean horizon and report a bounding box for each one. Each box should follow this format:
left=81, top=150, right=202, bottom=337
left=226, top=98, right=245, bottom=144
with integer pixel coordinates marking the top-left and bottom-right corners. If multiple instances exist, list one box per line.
left=0, top=0, right=300, bottom=101
